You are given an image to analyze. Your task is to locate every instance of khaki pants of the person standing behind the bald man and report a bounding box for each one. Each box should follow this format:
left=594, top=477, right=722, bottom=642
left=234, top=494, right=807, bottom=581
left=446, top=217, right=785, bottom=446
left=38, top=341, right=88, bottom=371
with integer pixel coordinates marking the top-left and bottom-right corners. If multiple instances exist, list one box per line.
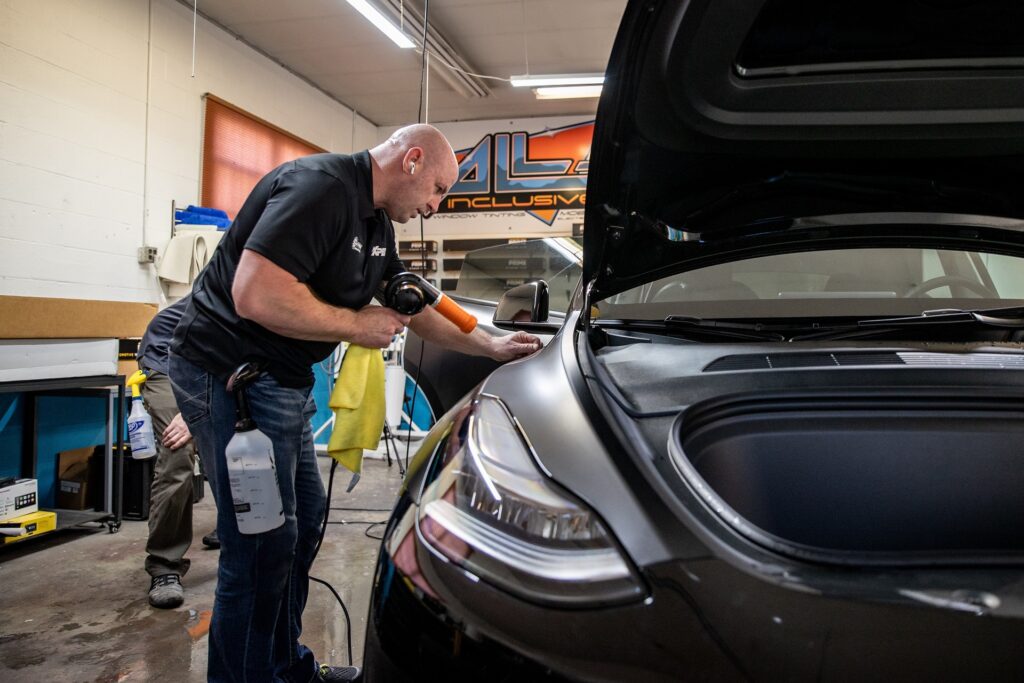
left=141, top=372, right=196, bottom=577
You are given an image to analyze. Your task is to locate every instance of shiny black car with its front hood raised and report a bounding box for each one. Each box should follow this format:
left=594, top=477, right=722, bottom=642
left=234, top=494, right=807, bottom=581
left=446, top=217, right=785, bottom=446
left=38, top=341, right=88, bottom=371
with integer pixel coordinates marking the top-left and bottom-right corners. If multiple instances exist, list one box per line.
left=364, top=0, right=1024, bottom=681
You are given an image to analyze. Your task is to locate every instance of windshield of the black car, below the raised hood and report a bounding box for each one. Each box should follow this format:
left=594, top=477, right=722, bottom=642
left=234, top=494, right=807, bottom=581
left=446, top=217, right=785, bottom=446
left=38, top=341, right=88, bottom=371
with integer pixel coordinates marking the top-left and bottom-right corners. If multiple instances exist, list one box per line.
left=600, top=248, right=1024, bottom=319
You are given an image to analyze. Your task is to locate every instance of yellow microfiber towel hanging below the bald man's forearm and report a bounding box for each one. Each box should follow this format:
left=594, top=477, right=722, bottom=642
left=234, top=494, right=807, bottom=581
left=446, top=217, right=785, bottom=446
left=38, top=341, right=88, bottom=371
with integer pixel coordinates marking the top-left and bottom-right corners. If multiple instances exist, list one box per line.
left=327, top=344, right=384, bottom=485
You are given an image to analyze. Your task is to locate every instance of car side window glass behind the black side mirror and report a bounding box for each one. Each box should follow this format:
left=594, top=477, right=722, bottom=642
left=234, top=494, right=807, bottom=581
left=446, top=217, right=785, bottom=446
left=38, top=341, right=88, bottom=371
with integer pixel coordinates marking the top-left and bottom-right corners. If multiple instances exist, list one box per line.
left=455, top=238, right=583, bottom=313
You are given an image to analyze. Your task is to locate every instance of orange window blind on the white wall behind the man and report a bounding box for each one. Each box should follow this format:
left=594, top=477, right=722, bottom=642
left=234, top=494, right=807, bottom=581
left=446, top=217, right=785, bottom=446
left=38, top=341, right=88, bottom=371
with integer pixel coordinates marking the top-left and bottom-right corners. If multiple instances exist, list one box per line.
left=201, top=94, right=325, bottom=218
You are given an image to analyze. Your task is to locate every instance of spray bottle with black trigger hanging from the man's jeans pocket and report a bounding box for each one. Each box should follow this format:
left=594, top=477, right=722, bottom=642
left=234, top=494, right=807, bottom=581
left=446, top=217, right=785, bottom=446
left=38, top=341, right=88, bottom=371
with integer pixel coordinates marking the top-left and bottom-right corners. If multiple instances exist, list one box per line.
left=224, top=362, right=285, bottom=533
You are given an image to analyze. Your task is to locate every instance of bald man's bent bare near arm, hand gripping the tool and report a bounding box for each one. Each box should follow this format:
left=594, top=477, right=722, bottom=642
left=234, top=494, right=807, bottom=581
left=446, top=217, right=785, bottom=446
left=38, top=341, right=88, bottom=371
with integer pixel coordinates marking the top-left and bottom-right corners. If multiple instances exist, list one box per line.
left=231, top=249, right=407, bottom=348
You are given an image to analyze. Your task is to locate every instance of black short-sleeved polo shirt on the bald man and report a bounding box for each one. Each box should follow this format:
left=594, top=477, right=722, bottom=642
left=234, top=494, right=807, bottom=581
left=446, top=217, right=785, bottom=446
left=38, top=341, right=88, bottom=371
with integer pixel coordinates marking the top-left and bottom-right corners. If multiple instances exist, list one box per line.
left=171, top=152, right=404, bottom=387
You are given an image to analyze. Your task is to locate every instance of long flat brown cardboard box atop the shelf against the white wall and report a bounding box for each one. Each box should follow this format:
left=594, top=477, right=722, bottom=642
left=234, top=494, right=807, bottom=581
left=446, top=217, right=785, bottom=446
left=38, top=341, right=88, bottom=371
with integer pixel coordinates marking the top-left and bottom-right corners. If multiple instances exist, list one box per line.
left=0, top=296, right=158, bottom=339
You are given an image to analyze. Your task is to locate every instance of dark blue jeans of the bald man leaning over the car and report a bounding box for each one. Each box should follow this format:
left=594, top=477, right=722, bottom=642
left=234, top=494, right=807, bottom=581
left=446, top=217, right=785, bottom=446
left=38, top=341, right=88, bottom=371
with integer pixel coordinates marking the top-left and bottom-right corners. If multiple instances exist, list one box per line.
left=169, top=352, right=327, bottom=683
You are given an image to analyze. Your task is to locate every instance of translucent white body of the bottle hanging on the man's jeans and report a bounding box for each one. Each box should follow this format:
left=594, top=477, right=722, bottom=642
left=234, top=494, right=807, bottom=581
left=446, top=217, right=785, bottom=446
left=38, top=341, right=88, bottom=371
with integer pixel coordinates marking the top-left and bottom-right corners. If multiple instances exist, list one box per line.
left=224, top=429, right=285, bottom=533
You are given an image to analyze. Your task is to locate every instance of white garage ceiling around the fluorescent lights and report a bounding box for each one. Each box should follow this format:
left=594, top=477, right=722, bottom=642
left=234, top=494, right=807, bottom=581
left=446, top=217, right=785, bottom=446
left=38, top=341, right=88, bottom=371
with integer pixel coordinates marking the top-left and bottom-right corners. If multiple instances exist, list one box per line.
left=189, top=0, right=626, bottom=126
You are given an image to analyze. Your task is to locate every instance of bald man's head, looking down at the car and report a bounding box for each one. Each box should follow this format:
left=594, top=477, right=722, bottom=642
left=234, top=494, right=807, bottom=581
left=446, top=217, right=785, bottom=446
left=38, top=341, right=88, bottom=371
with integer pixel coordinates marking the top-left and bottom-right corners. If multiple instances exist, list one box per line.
left=370, top=124, right=459, bottom=223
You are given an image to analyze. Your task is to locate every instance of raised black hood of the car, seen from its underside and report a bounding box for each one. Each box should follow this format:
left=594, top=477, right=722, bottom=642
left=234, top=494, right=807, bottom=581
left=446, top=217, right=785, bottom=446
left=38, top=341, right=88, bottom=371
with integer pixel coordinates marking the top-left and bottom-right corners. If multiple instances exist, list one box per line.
left=584, top=0, right=1024, bottom=299
